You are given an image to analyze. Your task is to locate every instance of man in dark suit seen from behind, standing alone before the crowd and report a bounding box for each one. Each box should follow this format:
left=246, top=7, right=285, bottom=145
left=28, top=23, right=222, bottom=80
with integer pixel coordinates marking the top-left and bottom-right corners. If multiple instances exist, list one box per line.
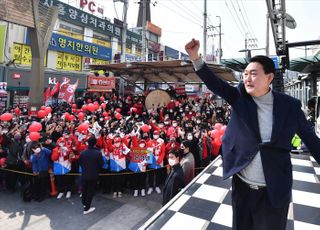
left=79, top=137, right=103, bottom=214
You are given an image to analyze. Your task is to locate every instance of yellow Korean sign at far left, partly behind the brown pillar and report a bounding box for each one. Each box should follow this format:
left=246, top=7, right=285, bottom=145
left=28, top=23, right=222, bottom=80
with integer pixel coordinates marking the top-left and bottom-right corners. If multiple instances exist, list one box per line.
left=12, top=43, right=47, bottom=66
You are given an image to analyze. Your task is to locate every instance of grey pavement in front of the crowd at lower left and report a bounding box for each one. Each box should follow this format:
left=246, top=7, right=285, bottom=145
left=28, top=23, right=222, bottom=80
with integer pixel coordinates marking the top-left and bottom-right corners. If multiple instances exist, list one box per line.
left=0, top=190, right=162, bottom=230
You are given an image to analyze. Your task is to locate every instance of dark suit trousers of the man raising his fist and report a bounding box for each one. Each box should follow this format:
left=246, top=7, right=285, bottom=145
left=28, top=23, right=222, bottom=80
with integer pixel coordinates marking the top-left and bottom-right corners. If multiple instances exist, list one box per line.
left=232, top=175, right=289, bottom=230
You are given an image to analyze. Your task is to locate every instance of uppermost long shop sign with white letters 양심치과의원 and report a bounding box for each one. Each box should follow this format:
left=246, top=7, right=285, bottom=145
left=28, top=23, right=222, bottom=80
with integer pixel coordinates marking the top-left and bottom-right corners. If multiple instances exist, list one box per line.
left=40, top=0, right=121, bottom=37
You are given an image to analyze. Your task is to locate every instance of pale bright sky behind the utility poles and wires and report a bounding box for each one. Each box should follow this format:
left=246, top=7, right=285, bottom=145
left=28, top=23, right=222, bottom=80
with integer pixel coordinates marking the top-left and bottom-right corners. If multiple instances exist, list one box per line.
left=63, top=0, right=320, bottom=58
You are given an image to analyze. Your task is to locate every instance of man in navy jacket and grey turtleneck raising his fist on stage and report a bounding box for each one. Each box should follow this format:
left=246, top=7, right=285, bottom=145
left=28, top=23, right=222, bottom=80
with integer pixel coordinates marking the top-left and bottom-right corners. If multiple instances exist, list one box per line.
left=185, top=39, right=320, bottom=230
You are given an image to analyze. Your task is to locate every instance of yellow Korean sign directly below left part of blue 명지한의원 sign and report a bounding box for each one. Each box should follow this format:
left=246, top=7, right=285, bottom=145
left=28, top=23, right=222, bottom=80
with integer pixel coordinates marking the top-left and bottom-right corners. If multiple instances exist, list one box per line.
left=56, top=52, right=82, bottom=71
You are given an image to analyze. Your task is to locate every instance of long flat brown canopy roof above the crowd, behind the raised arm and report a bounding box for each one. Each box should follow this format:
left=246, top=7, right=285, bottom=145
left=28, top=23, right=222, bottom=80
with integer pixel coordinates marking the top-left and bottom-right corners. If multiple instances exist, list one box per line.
left=90, top=60, right=238, bottom=83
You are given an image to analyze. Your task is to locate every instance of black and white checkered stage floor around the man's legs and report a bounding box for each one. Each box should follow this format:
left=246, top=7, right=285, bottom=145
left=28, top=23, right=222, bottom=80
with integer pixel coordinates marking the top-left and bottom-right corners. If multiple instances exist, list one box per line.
left=140, top=154, right=320, bottom=230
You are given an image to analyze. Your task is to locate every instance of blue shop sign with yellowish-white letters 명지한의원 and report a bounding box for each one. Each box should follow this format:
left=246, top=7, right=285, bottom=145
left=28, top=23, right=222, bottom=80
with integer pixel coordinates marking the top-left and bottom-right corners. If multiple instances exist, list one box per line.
left=48, top=33, right=112, bottom=60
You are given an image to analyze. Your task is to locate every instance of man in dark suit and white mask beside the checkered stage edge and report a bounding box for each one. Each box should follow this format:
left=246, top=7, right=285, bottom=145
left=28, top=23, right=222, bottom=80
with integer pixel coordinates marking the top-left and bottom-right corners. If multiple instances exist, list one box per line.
left=162, top=149, right=185, bottom=205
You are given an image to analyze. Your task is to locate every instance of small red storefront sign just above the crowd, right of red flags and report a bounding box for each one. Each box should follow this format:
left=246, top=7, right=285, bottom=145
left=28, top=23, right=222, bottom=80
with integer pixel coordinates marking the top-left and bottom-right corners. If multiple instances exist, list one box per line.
left=88, top=75, right=116, bottom=92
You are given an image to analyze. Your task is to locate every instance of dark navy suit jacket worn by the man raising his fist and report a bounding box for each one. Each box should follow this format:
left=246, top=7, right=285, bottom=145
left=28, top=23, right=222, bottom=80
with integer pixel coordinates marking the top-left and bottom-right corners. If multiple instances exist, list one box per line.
left=197, top=65, right=320, bottom=207
